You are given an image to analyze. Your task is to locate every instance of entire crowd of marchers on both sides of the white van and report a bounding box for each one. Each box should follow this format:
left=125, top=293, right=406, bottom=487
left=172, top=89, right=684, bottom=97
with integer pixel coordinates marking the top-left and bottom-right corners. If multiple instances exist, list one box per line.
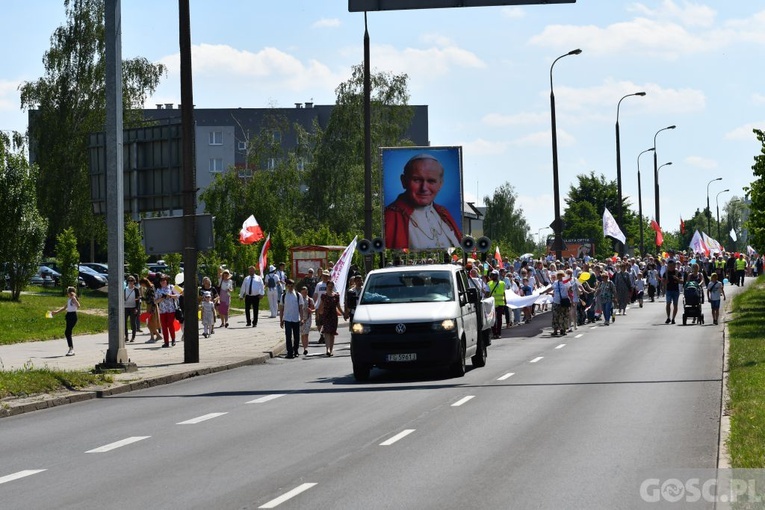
left=50, top=252, right=765, bottom=359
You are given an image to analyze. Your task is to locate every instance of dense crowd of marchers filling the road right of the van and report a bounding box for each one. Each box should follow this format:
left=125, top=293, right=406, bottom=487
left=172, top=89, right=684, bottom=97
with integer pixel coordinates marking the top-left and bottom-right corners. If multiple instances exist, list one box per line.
left=467, top=252, right=763, bottom=339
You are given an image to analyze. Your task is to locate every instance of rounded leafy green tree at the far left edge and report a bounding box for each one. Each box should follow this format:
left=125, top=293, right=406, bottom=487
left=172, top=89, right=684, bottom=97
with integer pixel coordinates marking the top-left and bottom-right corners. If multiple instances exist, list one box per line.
left=0, top=132, right=48, bottom=301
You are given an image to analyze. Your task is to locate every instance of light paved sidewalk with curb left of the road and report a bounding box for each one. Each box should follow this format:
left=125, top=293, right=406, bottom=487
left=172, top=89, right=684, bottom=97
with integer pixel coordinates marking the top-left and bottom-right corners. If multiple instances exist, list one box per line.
left=0, top=310, right=288, bottom=417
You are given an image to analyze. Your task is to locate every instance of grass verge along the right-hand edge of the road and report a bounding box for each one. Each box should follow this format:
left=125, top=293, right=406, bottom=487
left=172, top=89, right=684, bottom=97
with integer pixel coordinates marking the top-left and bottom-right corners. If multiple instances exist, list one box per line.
left=728, top=277, right=765, bottom=469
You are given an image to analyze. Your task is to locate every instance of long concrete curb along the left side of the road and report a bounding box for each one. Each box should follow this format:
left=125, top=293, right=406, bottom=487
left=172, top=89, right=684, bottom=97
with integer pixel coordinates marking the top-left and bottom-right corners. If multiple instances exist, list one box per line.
left=0, top=342, right=286, bottom=418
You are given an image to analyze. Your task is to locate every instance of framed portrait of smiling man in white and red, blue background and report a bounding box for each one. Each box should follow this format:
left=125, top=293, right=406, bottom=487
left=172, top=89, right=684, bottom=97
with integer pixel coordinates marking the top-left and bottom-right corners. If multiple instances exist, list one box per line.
left=381, top=147, right=463, bottom=251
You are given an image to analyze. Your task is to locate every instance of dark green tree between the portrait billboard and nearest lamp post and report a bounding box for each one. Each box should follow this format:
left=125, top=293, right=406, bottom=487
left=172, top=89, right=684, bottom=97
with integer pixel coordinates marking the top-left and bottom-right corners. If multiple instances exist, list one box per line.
left=483, top=182, right=534, bottom=258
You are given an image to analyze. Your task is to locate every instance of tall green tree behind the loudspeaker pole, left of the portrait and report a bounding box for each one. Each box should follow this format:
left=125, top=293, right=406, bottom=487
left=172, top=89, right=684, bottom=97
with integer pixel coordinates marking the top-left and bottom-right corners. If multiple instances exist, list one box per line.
left=305, top=65, right=414, bottom=232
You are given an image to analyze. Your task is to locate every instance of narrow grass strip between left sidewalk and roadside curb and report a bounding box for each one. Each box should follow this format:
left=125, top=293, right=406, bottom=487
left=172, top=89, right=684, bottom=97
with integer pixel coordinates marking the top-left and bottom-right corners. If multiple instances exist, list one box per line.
left=0, top=366, right=114, bottom=399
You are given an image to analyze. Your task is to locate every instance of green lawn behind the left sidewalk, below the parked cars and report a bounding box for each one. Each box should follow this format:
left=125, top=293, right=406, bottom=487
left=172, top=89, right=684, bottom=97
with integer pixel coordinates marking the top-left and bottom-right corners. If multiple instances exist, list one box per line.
left=0, top=288, right=108, bottom=345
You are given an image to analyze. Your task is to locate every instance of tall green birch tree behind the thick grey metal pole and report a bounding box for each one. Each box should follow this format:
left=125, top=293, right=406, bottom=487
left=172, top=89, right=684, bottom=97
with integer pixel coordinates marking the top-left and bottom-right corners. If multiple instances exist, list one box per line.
left=21, top=0, right=165, bottom=251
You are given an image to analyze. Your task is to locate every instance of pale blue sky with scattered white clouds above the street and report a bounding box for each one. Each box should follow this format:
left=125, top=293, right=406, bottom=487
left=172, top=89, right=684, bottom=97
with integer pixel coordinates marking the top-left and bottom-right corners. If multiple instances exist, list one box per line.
left=0, top=0, right=765, bottom=245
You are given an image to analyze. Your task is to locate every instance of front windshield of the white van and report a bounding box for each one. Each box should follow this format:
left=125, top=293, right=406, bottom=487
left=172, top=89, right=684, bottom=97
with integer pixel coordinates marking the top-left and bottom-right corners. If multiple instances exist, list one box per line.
left=361, top=271, right=454, bottom=305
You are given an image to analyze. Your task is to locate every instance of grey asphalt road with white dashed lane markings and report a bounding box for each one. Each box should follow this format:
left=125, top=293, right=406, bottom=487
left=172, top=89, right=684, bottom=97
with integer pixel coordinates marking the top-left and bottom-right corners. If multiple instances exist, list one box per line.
left=0, top=284, right=740, bottom=509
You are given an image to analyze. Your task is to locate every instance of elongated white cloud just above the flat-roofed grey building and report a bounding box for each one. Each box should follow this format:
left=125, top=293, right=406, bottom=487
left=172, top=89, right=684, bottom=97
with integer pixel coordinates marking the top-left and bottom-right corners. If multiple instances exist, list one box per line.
left=161, top=44, right=344, bottom=90
